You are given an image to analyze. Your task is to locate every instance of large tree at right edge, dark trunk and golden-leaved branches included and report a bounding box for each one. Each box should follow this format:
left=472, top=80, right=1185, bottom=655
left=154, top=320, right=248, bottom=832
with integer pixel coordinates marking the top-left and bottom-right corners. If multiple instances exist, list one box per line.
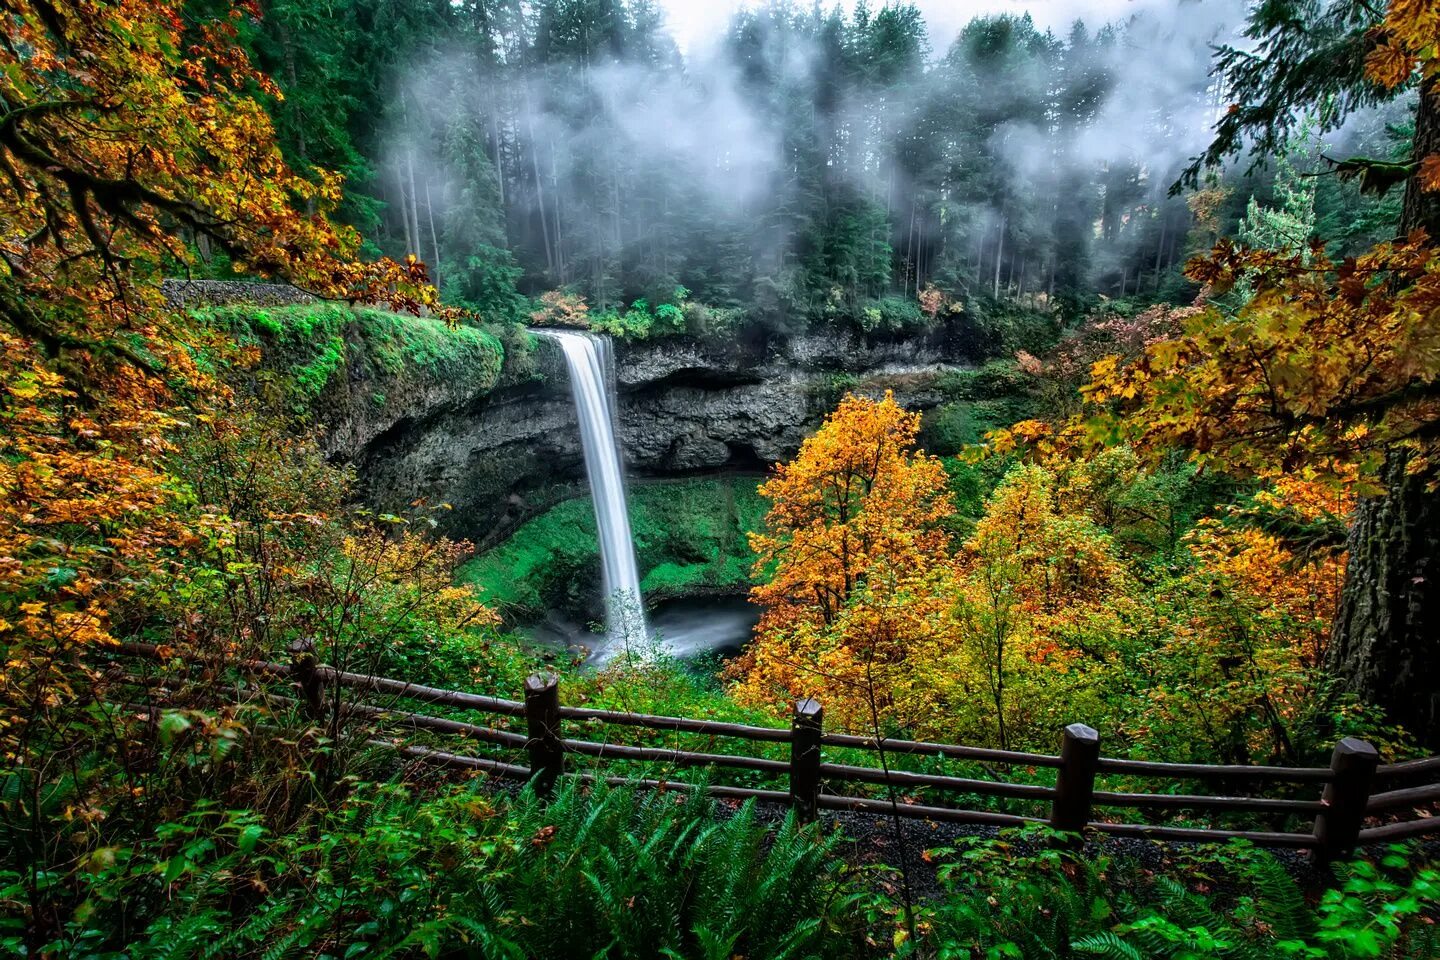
left=994, top=0, right=1440, bottom=746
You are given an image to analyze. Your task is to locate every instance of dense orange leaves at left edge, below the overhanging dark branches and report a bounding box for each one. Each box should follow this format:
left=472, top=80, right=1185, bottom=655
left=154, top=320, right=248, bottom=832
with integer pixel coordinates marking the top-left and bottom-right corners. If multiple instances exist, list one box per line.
left=0, top=331, right=204, bottom=719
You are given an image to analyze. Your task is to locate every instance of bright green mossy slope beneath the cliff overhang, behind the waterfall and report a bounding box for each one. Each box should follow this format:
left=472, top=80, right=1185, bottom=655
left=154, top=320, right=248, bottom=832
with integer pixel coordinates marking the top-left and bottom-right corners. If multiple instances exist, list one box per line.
left=458, top=476, right=766, bottom=619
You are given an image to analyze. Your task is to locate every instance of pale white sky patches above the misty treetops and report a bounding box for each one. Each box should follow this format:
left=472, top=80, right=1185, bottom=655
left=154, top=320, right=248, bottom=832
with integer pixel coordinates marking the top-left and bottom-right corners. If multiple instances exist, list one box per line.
left=661, top=0, right=1175, bottom=53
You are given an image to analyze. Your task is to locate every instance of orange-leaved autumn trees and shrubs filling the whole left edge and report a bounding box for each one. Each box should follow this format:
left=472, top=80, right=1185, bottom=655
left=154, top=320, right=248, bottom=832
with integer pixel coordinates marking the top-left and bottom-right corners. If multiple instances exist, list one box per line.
left=0, top=0, right=501, bottom=950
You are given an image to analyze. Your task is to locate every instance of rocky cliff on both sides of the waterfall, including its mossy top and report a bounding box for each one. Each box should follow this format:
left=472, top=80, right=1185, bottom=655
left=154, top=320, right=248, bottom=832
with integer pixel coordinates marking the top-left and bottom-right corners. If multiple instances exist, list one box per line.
left=163, top=281, right=984, bottom=545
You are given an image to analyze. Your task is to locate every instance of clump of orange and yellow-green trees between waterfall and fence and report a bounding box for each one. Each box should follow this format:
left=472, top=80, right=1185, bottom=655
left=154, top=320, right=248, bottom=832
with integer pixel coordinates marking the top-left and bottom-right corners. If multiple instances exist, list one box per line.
left=729, top=396, right=1139, bottom=746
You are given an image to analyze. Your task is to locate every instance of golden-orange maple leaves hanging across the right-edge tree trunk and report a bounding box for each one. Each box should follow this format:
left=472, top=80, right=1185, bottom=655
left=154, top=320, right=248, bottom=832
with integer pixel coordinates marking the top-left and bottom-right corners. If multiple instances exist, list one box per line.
left=1077, top=237, right=1440, bottom=488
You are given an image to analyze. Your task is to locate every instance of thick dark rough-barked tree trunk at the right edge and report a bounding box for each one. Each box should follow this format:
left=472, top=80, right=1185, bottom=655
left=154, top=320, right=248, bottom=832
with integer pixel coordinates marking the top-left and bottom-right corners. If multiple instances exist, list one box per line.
left=1328, top=79, right=1440, bottom=748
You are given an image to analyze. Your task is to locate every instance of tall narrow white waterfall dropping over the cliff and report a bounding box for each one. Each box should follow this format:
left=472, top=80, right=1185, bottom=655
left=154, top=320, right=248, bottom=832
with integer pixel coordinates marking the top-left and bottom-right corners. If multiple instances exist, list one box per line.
left=534, top=330, right=649, bottom=642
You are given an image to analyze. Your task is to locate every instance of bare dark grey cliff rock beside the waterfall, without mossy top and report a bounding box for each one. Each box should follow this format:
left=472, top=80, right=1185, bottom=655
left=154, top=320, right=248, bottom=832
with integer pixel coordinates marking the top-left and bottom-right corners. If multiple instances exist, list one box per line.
left=354, top=335, right=969, bottom=544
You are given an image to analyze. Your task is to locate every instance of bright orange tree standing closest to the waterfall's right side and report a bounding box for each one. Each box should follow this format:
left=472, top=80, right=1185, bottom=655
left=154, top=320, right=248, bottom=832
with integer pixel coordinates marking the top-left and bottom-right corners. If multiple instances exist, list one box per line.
left=732, top=393, right=953, bottom=724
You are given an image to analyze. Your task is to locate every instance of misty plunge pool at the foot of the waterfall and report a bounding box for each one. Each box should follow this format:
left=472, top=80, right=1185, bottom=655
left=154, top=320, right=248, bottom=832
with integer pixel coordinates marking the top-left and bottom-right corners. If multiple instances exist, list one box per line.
left=521, top=597, right=760, bottom=668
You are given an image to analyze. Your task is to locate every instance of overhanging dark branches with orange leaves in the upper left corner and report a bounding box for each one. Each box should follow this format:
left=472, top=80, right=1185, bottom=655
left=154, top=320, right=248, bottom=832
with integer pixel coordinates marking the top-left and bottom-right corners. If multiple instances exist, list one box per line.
left=0, top=0, right=438, bottom=341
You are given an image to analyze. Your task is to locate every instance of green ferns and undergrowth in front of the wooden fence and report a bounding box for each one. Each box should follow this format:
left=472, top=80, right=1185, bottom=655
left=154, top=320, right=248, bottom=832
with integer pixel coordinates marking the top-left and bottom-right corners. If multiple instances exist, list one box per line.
left=11, top=693, right=1440, bottom=960
